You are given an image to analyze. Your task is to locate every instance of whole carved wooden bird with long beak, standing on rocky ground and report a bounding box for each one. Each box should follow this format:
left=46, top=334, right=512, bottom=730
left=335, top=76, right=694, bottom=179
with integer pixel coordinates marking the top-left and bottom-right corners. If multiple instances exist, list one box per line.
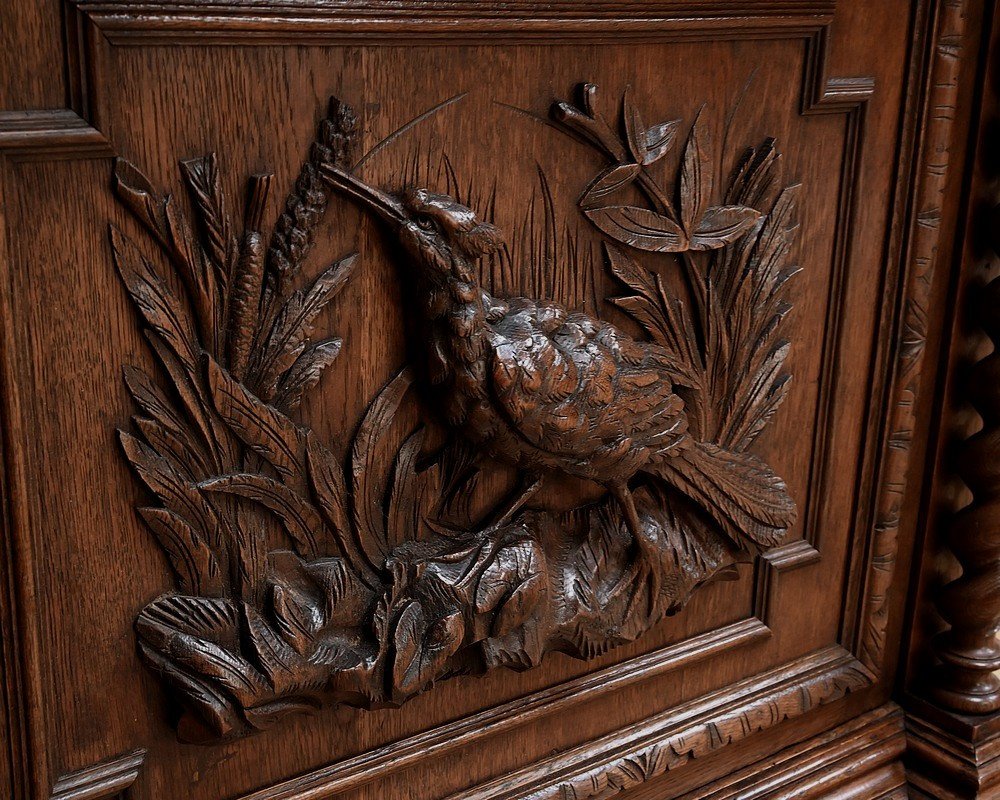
left=324, top=166, right=795, bottom=550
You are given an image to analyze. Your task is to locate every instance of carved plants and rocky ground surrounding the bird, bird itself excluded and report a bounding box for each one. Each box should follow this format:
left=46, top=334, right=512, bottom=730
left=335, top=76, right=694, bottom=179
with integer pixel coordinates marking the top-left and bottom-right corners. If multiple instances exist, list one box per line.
left=111, top=85, right=798, bottom=742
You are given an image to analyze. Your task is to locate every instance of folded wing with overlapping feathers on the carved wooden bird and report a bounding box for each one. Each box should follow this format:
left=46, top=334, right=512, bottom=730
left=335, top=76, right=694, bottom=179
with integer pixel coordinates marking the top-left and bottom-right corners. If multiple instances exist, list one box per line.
left=491, top=299, right=685, bottom=461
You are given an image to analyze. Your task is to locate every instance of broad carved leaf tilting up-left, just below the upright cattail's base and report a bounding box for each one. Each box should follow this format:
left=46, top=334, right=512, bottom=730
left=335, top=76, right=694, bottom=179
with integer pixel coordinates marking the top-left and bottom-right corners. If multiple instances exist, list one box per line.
left=205, top=358, right=305, bottom=483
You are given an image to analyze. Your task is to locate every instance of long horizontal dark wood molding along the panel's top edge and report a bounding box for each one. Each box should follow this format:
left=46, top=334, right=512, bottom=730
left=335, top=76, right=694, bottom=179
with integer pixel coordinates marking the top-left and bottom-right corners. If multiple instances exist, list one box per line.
left=68, top=0, right=836, bottom=45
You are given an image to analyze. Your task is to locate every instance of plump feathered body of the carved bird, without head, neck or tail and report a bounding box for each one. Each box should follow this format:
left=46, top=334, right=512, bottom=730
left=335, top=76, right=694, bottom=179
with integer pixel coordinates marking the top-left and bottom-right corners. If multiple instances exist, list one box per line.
left=425, top=287, right=689, bottom=483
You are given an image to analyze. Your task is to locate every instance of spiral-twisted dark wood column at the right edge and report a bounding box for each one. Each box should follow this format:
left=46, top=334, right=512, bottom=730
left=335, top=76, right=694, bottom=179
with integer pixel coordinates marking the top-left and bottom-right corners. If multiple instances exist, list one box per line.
left=930, top=241, right=1000, bottom=714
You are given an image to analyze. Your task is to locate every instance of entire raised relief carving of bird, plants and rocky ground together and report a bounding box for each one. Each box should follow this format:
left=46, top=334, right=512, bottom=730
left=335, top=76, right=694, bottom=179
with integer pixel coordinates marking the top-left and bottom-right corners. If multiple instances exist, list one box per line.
left=111, top=85, right=797, bottom=741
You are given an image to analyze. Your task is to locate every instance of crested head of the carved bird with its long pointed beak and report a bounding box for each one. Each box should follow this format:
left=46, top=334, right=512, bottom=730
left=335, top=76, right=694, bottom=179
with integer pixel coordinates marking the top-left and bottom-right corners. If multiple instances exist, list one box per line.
left=323, top=166, right=503, bottom=280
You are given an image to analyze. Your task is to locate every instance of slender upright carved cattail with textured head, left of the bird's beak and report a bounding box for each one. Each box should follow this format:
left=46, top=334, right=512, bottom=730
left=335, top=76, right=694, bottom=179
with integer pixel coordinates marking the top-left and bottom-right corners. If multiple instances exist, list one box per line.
left=228, top=175, right=273, bottom=381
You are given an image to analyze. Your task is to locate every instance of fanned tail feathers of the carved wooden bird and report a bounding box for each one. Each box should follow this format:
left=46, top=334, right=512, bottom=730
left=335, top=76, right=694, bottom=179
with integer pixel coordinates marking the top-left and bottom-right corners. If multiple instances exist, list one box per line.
left=645, top=442, right=796, bottom=550
